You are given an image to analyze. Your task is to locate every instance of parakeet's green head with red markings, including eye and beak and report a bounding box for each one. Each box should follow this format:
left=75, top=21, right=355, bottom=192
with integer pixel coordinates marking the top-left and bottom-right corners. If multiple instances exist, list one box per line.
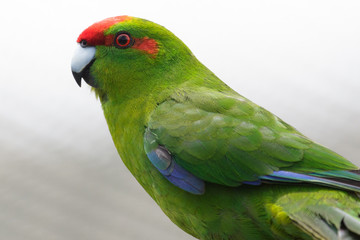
left=71, top=16, right=195, bottom=98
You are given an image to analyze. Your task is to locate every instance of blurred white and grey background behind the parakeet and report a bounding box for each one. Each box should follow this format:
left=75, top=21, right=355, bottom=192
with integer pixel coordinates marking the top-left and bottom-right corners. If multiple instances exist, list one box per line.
left=0, top=0, right=360, bottom=240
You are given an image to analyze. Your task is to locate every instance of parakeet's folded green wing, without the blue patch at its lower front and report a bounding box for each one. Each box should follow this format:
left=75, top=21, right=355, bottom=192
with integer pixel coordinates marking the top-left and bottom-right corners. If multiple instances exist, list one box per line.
left=144, top=88, right=357, bottom=192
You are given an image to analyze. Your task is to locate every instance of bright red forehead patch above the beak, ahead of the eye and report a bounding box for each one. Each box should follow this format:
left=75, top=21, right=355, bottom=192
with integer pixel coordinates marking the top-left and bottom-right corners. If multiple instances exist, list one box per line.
left=77, top=16, right=131, bottom=46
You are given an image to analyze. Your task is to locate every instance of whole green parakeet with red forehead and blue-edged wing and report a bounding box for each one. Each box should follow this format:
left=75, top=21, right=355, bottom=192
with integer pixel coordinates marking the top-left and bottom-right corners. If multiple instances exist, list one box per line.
left=71, top=16, right=360, bottom=240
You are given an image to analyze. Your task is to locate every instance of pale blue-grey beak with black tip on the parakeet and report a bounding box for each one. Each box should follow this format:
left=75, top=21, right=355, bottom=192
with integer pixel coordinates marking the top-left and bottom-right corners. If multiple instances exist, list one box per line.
left=71, top=43, right=96, bottom=87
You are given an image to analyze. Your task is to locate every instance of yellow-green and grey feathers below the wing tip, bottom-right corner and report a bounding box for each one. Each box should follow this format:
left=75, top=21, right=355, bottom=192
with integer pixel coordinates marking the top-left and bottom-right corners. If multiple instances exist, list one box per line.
left=267, top=184, right=360, bottom=240
